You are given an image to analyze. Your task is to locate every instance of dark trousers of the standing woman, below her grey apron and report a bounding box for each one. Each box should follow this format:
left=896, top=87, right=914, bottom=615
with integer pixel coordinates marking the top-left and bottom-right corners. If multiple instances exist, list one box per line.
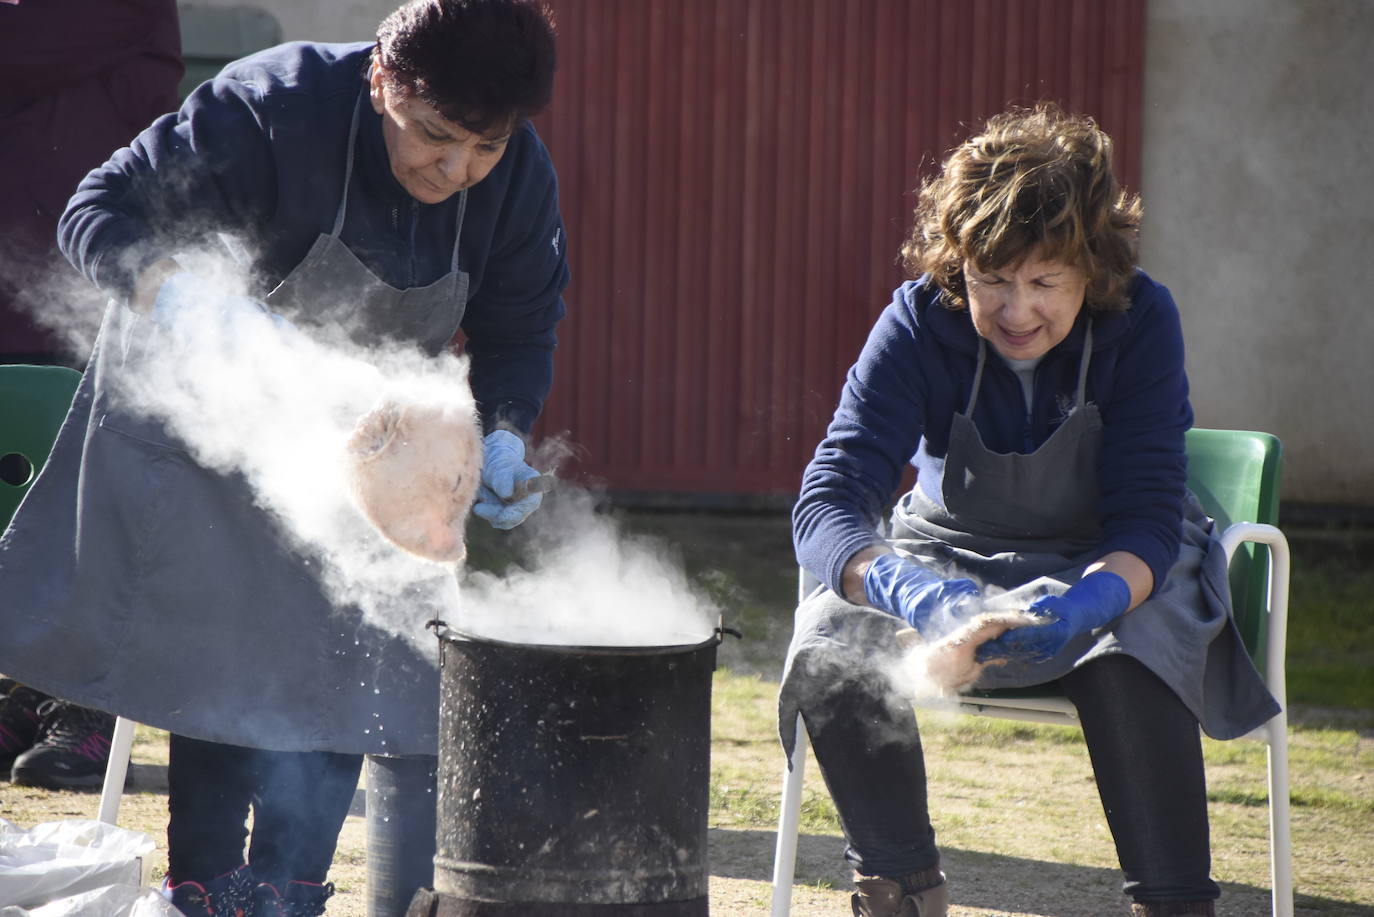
left=168, top=736, right=363, bottom=888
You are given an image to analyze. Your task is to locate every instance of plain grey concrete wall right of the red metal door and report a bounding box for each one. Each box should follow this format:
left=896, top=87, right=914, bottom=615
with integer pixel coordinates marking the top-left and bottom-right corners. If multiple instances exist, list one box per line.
left=1140, top=0, right=1374, bottom=506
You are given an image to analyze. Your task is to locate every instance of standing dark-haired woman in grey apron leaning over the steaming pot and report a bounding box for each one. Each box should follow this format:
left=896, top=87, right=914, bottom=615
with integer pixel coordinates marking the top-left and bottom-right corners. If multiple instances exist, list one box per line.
left=0, top=0, right=567, bottom=916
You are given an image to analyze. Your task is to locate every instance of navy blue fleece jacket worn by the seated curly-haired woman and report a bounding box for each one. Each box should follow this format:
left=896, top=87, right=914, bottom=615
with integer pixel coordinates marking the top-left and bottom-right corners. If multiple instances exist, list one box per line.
left=793, top=272, right=1193, bottom=593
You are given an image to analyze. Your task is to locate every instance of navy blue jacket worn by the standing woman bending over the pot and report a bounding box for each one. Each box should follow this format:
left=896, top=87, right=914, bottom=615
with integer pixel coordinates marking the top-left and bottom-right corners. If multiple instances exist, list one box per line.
left=58, top=41, right=569, bottom=432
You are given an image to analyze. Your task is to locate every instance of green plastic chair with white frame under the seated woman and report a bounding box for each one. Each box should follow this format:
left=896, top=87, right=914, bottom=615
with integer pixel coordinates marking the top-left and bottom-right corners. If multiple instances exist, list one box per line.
left=771, top=429, right=1293, bottom=917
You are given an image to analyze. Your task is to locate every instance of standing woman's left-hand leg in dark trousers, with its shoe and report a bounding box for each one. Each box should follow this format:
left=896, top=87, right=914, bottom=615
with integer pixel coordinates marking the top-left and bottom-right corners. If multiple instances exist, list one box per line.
left=164, top=734, right=258, bottom=917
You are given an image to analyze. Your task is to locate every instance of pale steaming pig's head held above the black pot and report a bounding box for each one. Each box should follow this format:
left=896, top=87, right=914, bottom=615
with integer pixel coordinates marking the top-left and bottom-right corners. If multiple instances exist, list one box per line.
left=346, top=399, right=482, bottom=564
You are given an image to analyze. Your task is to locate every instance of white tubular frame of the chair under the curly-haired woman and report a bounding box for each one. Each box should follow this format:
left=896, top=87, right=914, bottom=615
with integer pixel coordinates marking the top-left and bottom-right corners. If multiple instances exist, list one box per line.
left=771, top=522, right=1293, bottom=917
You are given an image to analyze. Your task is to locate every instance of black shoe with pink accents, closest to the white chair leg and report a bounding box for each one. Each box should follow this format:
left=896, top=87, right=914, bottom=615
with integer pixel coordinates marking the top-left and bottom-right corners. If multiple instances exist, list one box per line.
left=10, top=698, right=114, bottom=789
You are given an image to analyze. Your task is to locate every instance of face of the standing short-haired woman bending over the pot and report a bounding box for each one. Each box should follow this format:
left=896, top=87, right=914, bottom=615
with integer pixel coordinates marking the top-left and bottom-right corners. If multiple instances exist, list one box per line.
left=371, top=66, right=510, bottom=203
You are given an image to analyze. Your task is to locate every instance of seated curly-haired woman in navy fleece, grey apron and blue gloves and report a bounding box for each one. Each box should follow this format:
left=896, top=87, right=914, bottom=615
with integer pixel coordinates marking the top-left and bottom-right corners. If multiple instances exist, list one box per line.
left=780, top=106, right=1278, bottom=917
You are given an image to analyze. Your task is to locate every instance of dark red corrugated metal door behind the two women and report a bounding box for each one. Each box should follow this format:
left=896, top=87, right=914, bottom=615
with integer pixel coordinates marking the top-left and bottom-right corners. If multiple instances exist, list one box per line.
left=537, top=0, right=1145, bottom=495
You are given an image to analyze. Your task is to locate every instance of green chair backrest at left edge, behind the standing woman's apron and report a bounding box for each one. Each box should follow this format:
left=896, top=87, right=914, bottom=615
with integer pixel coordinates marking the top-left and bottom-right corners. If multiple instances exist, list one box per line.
left=0, top=364, right=81, bottom=531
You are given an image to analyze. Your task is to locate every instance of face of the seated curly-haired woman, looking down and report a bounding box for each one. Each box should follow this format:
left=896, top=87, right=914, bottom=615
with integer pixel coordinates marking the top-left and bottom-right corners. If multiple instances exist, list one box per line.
left=963, top=252, right=1088, bottom=360
